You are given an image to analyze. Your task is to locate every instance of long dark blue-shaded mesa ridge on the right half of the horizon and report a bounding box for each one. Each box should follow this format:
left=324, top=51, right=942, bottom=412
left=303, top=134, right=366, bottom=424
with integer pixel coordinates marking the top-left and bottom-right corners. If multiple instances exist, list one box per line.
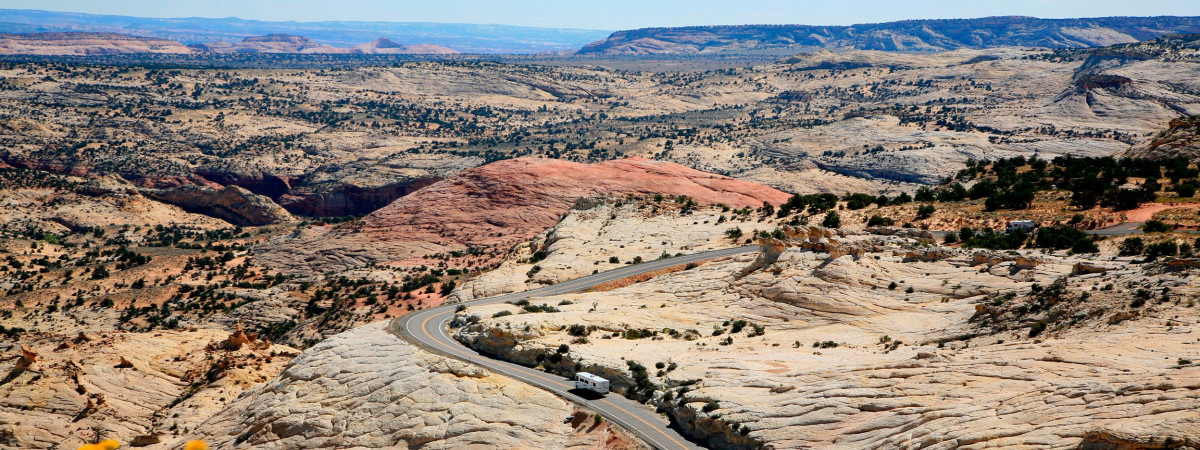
left=577, top=16, right=1200, bottom=55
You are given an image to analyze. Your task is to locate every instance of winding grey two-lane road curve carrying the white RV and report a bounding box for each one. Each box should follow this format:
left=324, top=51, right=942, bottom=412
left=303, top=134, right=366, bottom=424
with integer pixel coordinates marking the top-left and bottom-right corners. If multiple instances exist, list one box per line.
left=391, top=245, right=758, bottom=449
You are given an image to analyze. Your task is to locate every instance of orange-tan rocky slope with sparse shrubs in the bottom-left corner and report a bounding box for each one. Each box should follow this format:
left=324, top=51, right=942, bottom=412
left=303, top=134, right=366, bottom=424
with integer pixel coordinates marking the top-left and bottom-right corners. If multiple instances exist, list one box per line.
left=0, top=329, right=299, bottom=449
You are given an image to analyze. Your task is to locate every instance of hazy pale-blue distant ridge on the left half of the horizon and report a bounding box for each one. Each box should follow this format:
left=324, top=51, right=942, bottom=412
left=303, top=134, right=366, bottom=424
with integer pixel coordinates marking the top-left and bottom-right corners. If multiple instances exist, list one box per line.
left=0, top=10, right=611, bottom=53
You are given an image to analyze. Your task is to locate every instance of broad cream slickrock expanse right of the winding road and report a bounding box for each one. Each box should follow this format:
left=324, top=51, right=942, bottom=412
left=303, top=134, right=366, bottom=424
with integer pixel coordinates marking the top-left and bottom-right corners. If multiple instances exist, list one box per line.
left=455, top=227, right=1200, bottom=449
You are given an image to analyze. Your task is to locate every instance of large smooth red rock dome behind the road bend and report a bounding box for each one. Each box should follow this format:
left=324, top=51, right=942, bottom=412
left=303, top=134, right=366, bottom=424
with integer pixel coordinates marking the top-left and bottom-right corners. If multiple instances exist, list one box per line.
left=256, top=157, right=788, bottom=272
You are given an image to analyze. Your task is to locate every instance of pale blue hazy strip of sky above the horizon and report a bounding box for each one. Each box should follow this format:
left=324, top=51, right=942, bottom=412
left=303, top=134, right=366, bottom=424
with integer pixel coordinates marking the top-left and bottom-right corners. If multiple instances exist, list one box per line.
left=7, top=0, right=1200, bottom=30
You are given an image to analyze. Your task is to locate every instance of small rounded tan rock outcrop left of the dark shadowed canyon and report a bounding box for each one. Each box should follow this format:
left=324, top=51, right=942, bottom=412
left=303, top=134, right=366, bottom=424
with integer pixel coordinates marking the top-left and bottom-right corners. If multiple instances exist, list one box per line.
left=140, top=185, right=293, bottom=226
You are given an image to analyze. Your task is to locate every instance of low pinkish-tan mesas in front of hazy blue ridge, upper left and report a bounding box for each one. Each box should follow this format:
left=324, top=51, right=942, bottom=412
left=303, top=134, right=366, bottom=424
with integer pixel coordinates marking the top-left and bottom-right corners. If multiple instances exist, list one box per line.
left=0, top=32, right=458, bottom=56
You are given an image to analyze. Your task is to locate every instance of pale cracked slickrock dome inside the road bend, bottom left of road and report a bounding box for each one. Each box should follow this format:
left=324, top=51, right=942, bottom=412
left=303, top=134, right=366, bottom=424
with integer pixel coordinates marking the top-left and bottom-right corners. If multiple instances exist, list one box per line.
left=179, top=322, right=643, bottom=449
